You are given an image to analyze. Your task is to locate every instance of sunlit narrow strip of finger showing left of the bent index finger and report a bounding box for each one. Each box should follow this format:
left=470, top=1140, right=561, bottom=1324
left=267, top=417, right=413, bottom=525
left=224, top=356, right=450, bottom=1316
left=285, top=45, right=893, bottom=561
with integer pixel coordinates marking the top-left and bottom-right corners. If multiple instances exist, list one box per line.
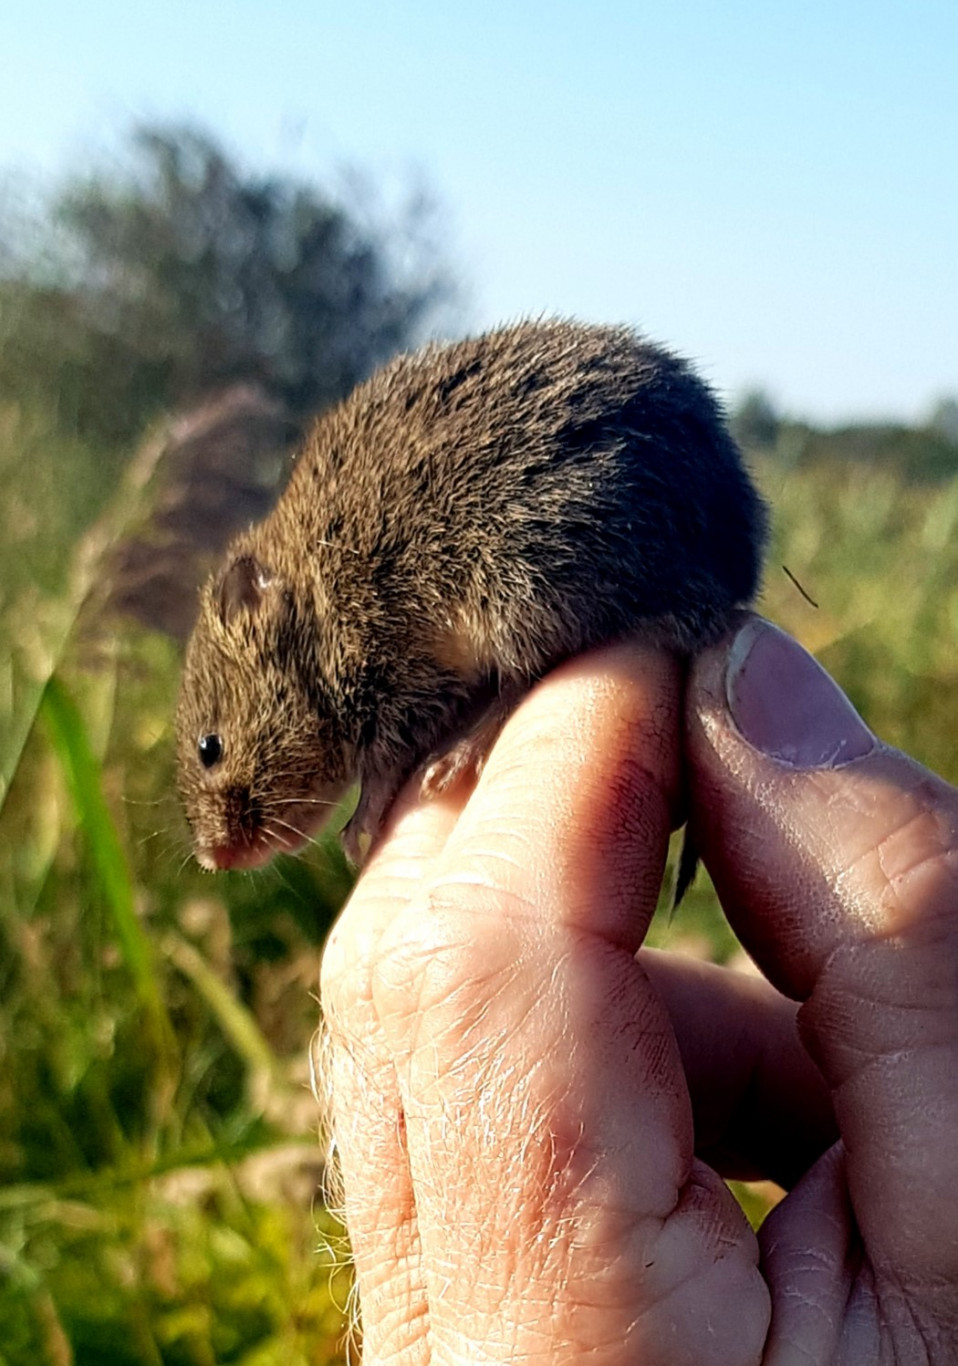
left=316, top=783, right=465, bottom=1366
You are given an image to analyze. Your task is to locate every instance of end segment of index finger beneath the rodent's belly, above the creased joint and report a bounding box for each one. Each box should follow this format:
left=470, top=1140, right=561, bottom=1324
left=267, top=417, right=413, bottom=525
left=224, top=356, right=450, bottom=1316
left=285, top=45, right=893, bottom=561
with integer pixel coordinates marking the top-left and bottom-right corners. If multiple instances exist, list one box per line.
left=415, top=642, right=682, bottom=952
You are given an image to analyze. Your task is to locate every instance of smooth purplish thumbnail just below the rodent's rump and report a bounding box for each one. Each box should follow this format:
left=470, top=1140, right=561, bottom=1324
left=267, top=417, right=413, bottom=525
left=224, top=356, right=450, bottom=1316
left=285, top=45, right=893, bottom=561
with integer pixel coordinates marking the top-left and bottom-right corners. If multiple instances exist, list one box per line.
left=726, top=617, right=876, bottom=769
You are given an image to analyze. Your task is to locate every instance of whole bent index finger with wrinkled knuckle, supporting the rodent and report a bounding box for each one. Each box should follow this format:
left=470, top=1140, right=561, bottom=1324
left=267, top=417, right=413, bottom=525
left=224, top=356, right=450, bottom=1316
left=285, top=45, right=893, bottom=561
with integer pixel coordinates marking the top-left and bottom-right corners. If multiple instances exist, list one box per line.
left=366, top=645, right=768, bottom=1366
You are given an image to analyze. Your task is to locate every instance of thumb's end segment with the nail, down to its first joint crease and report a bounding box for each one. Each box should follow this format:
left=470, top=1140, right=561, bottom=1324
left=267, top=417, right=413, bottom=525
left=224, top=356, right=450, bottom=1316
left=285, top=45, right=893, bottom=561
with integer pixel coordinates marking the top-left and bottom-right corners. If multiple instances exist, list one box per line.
left=686, top=616, right=958, bottom=1000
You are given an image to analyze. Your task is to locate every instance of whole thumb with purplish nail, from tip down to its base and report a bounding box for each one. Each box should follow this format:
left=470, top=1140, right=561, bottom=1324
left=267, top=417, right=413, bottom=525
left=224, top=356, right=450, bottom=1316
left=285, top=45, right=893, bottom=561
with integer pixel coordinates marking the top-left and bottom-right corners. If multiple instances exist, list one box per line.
left=686, top=617, right=958, bottom=1320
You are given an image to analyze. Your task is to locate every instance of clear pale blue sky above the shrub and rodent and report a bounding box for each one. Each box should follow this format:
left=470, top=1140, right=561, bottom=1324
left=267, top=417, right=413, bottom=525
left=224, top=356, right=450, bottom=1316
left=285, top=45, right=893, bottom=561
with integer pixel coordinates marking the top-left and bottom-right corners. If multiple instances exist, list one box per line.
left=0, top=0, right=958, bottom=419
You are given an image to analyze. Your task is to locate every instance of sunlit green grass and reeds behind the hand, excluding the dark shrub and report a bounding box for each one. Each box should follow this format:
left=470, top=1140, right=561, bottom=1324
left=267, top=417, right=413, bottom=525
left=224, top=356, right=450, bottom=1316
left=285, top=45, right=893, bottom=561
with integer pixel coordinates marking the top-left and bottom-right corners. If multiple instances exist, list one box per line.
left=0, top=408, right=958, bottom=1366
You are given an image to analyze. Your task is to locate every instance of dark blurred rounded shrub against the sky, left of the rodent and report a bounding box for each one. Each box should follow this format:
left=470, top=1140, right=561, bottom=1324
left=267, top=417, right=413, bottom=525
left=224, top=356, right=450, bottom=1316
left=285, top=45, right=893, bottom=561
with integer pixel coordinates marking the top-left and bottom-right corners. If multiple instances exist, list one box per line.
left=0, top=126, right=452, bottom=445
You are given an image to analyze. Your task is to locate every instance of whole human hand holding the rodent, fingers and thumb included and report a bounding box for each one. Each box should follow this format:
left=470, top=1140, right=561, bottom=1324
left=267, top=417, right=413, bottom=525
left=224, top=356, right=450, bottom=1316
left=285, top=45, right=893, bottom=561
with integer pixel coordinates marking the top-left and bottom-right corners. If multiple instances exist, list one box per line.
left=323, top=624, right=958, bottom=1366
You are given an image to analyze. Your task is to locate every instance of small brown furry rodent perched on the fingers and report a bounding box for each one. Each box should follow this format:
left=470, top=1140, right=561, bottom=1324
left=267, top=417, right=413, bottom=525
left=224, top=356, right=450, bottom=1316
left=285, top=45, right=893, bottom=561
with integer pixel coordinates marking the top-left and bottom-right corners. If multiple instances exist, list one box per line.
left=178, top=321, right=765, bottom=869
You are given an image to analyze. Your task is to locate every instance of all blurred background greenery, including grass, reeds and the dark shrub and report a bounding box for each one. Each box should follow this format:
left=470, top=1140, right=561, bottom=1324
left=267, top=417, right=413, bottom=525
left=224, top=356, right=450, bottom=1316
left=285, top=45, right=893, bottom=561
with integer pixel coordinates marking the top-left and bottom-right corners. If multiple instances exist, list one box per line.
left=0, top=128, right=958, bottom=1366
